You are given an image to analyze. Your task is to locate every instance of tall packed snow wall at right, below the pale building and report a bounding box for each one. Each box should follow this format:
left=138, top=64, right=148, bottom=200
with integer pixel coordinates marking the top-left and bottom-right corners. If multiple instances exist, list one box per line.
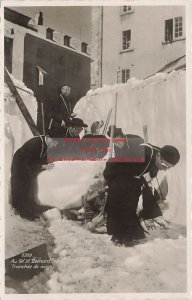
left=75, top=70, right=186, bottom=224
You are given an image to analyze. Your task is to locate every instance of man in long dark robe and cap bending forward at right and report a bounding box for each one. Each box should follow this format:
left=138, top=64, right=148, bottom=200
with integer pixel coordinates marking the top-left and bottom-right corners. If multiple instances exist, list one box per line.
left=104, top=128, right=180, bottom=245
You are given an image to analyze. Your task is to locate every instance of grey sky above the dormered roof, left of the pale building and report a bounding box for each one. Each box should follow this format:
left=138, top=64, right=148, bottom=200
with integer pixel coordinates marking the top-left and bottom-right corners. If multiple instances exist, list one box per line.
left=10, top=6, right=91, bottom=44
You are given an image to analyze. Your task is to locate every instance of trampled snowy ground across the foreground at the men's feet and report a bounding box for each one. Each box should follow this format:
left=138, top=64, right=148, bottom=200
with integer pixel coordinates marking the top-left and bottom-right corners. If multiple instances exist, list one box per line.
left=6, top=207, right=187, bottom=294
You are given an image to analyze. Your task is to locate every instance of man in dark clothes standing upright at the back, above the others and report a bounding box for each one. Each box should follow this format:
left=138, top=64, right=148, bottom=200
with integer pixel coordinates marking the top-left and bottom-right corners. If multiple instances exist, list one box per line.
left=49, top=86, right=75, bottom=137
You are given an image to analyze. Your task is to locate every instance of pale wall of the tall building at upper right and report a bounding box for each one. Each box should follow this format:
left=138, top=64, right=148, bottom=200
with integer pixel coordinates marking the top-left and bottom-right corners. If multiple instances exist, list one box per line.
left=100, top=6, right=185, bottom=84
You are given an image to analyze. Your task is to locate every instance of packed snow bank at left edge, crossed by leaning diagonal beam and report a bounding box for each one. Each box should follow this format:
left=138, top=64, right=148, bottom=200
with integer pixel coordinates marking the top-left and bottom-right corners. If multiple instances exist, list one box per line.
left=4, top=76, right=37, bottom=202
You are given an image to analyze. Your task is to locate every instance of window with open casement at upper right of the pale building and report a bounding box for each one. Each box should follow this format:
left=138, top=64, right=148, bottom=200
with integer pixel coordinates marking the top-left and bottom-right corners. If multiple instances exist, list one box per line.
left=165, top=17, right=183, bottom=43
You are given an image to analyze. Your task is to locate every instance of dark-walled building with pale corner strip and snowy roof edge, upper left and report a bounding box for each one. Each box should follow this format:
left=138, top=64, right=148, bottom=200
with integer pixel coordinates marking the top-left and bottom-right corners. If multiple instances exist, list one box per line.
left=4, top=9, right=91, bottom=132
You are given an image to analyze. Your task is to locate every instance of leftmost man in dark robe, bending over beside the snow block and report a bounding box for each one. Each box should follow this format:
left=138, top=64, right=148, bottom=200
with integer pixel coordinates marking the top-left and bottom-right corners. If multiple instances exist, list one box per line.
left=11, top=136, right=57, bottom=220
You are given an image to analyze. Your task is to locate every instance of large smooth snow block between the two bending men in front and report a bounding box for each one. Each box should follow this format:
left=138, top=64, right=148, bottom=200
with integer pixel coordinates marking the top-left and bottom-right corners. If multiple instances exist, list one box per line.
left=38, top=161, right=105, bottom=208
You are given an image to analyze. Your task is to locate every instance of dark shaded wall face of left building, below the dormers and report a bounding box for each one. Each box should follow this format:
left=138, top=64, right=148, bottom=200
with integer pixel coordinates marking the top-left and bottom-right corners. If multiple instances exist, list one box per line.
left=23, top=34, right=90, bottom=130
